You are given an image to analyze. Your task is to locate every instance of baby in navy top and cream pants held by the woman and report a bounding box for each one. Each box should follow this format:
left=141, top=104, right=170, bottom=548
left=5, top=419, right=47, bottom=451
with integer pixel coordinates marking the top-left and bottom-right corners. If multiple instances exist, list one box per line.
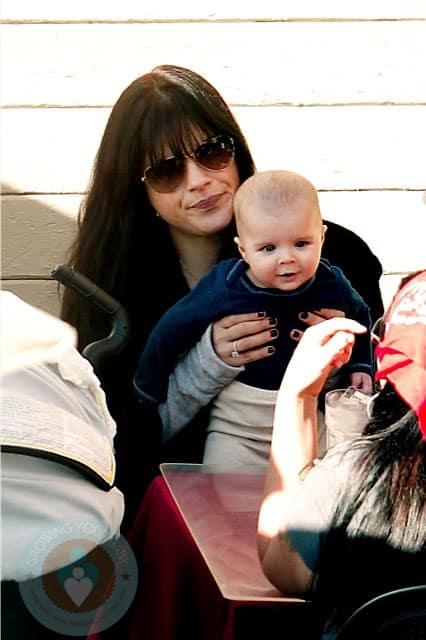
left=134, top=170, right=373, bottom=467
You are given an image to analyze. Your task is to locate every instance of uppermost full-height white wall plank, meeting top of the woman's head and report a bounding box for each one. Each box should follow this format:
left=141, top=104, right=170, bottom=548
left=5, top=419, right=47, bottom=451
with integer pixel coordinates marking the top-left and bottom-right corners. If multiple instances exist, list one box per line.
left=1, top=22, right=426, bottom=106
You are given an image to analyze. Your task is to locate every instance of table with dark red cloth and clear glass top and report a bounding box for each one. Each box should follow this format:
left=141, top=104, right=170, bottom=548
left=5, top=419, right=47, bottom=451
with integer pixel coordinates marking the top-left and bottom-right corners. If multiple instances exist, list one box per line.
left=123, top=464, right=317, bottom=640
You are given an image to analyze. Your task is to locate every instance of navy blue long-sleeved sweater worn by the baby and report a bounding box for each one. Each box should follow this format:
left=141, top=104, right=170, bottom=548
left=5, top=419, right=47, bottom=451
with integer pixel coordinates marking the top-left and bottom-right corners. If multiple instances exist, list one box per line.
left=134, top=258, right=372, bottom=403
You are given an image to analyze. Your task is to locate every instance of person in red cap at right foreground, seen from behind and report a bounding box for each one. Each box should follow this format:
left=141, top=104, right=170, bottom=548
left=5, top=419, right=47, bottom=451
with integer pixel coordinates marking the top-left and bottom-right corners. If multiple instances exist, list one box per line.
left=258, top=271, right=426, bottom=638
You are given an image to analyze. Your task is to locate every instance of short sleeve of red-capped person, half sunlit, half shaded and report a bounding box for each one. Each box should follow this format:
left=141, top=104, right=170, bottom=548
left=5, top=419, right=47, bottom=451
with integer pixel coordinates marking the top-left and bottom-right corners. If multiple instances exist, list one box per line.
left=282, top=443, right=349, bottom=572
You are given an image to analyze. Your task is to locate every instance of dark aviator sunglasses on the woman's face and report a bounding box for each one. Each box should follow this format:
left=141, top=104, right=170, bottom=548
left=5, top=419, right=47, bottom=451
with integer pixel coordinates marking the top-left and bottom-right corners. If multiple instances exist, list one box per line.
left=141, top=134, right=235, bottom=193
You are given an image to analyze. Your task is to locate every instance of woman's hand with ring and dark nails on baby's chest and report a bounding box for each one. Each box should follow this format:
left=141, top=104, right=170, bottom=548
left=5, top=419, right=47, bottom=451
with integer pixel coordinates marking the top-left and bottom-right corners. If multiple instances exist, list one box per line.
left=212, top=311, right=278, bottom=367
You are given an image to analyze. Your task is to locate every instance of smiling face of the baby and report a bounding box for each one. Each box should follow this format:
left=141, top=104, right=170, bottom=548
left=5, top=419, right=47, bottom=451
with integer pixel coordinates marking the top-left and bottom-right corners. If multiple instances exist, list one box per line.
left=237, top=199, right=325, bottom=291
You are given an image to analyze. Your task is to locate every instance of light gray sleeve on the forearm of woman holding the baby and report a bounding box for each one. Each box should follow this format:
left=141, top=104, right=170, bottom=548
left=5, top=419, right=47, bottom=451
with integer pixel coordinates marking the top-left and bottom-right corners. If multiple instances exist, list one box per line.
left=158, top=325, right=244, bottom=443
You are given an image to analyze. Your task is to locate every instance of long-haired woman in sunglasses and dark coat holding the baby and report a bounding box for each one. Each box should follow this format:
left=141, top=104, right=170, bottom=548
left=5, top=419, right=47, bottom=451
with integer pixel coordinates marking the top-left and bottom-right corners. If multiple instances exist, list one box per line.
left=61, top=65, right=381, bottom=532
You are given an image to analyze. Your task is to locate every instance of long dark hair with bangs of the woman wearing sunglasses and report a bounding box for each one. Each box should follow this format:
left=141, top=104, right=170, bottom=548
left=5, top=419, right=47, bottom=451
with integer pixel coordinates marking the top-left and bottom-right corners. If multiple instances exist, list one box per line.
left=61, top=65, right=255, bottom=347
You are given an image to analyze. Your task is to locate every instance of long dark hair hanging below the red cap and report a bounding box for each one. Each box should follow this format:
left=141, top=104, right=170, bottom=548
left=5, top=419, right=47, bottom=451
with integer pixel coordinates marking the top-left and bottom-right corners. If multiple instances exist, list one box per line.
left=317, top=383, right=426, bottom=623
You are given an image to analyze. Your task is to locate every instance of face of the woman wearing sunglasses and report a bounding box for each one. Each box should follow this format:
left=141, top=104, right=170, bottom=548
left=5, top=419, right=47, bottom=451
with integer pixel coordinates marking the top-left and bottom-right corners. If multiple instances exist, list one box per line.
left=145, top=134, right=240, bottom=236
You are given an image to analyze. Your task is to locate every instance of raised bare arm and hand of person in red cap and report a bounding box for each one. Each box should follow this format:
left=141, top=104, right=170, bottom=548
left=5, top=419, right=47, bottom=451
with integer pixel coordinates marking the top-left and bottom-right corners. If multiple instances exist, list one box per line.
left=257, top=317, right=367, bottom=595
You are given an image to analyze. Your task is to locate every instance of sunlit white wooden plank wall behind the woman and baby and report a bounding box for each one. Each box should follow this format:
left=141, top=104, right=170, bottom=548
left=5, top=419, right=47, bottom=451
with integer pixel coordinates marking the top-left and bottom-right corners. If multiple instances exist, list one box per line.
left=0, top=0, right=426, bottom=313
